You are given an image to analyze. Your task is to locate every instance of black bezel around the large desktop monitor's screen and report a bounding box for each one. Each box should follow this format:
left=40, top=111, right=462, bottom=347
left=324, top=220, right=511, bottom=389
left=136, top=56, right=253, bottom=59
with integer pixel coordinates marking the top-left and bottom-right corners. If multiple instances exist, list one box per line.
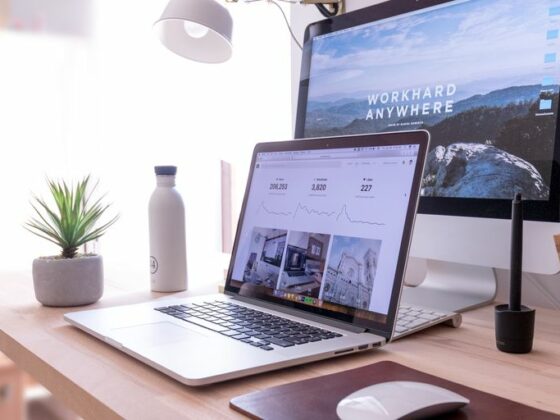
left=295, top=0, right=560, bottom=222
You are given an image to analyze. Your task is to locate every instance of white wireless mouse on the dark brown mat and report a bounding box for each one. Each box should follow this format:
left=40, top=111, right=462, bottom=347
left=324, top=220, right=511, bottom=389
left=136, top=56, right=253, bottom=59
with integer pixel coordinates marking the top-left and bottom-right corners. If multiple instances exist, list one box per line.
left=336, top=381, right=469, bottom=420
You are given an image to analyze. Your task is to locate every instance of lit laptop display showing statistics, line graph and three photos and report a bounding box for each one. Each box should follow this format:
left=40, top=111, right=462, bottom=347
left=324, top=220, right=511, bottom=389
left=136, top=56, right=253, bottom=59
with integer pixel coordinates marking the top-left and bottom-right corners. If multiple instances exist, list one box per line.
left=230, top=145, right=419, bottom=322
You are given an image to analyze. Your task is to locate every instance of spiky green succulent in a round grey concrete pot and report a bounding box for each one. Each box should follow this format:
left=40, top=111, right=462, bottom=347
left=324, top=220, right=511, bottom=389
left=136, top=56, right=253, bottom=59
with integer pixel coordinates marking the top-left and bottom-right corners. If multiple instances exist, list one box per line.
left=25, top=176, right=118, bottom=306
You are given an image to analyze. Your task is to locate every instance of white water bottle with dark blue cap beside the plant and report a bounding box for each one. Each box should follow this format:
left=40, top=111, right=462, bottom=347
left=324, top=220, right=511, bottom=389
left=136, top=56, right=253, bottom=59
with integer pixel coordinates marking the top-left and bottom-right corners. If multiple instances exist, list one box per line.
left=149, top=166, right=187, bottom=292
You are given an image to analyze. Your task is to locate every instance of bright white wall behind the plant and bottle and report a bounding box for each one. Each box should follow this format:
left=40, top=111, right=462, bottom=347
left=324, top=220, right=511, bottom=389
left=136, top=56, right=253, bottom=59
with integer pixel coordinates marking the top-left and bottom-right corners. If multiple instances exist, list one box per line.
left=0, top=0, right=291, bottom=287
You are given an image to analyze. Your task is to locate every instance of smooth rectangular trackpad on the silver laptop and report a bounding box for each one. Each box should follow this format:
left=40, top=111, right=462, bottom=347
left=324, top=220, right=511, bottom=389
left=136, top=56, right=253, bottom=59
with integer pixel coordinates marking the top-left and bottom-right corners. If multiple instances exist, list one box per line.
left=110, top=322, right=206, bottom=347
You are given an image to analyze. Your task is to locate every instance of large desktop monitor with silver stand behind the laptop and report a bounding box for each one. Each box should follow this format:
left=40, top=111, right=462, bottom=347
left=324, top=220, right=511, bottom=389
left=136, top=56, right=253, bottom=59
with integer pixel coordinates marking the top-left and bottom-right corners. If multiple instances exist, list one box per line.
left=296, top=0, right=560, bottom=311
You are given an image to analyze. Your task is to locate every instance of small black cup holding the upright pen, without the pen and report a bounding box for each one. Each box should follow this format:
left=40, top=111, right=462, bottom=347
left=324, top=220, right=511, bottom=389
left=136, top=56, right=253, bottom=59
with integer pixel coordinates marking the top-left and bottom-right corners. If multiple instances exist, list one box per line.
left=495, top=305, right=535, bottom=353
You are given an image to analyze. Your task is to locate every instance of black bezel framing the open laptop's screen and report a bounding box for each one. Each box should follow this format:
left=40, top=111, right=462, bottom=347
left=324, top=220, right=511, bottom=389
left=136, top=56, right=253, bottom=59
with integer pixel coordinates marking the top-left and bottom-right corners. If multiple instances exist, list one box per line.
left=224, top=130, right=429, bottom=340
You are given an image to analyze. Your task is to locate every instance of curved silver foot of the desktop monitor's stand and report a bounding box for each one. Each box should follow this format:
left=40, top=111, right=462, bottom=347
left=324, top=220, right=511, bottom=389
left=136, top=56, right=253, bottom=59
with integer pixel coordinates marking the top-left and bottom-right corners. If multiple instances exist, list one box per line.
left=401, top=260, right=496, bottom=312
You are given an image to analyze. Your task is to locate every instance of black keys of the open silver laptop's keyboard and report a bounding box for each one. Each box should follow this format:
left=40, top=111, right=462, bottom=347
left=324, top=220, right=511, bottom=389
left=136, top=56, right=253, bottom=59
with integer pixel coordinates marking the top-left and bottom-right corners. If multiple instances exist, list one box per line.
left=154, top=301, right=342, bottom=351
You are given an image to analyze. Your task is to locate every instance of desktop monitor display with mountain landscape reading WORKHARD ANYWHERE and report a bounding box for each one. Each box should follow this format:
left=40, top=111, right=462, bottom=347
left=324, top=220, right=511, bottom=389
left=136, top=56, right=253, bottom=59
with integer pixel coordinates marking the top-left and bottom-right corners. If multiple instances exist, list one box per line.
left=303, top=0, right=560, bottom=201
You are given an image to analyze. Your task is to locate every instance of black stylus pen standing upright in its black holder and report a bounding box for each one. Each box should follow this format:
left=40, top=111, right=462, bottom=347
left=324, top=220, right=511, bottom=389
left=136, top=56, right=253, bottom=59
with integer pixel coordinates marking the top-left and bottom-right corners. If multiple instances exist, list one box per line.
left=495, top=193, right=535, bottom=353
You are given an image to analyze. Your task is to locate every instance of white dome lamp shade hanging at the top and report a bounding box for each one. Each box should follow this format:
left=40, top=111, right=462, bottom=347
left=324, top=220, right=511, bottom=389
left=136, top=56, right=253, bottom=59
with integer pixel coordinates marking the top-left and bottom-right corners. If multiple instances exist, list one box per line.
left=154, top=0, right=233, bottom=63
